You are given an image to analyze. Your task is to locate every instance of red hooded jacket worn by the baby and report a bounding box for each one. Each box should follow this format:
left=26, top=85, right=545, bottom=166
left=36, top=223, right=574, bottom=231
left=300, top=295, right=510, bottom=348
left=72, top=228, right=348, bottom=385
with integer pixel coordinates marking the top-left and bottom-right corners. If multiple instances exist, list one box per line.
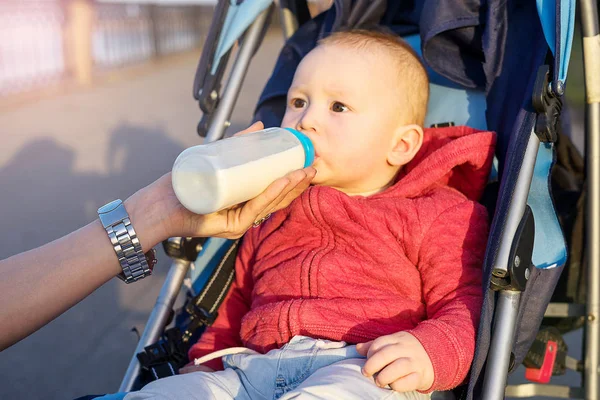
left=189, top=127, right=495, bottom=390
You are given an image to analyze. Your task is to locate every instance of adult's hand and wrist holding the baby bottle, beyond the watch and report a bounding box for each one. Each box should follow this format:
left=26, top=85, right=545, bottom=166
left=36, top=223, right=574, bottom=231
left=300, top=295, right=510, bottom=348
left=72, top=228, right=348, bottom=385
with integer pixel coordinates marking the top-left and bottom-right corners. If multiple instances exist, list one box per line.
left=125, top=122, right=316, bottom=249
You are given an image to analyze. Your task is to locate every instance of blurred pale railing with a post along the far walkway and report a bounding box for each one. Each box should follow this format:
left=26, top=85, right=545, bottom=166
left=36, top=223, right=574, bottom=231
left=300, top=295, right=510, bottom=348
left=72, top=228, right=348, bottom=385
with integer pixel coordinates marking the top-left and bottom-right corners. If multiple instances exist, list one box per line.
left=0, top=0, right=213, bottom=97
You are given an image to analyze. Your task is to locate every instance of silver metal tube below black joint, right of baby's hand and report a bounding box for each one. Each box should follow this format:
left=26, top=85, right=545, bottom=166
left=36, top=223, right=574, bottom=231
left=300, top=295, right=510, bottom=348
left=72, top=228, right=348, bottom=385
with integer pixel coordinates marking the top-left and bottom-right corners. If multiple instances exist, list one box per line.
left=481, top=290, right=521, bottom=400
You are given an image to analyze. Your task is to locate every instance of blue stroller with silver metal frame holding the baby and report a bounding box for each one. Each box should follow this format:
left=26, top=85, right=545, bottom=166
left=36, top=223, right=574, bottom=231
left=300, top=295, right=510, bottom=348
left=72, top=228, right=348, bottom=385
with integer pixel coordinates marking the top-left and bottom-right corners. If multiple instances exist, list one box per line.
left=113, top=0, right=600, bottom=400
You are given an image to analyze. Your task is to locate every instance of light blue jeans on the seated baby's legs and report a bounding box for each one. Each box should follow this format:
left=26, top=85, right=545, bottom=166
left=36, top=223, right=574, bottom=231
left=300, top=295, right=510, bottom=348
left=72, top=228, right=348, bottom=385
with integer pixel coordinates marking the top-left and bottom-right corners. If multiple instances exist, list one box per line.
left=125, top=336, right=430, bottom=400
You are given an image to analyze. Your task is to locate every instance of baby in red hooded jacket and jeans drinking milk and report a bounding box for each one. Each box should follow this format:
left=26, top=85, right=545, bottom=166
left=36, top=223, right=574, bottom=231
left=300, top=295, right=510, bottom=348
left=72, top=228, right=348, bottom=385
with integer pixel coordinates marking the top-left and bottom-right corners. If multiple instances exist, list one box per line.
left=127, top=31, right=495, bottom=399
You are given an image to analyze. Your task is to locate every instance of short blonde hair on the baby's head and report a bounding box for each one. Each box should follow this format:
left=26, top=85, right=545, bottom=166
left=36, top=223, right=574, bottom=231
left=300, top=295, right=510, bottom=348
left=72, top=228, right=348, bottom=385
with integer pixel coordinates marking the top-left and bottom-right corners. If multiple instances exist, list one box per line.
left=319, top=29, right=429, bottom=126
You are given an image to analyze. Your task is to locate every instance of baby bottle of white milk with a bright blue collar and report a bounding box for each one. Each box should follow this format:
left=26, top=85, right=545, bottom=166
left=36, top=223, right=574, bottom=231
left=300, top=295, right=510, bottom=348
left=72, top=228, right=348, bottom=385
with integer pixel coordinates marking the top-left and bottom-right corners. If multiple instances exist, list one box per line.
left=172, top=128, right=315, bottom=214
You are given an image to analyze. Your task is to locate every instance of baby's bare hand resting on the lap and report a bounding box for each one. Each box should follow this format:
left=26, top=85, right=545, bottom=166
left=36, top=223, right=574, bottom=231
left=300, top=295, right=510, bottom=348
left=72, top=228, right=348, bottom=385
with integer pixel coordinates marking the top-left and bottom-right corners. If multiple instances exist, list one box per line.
left=356, top=332, right=434, bottom=392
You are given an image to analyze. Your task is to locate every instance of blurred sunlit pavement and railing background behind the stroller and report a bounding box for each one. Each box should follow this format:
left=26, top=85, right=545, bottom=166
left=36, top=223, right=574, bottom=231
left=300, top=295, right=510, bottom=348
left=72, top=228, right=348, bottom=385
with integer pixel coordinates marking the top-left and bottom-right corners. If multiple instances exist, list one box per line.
left=0, top=0, right=584, bottom=399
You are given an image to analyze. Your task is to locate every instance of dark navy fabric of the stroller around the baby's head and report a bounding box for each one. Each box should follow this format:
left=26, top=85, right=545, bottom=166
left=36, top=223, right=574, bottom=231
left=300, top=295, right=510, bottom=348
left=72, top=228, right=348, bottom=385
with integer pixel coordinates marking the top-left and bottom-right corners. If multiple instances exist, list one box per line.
left=254, top=0, right=564, bottom=399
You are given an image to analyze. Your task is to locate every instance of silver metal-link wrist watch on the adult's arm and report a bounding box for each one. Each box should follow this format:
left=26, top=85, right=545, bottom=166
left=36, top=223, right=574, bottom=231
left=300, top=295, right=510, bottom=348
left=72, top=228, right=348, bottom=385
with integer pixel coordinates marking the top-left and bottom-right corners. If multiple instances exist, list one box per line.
left=98, top=200, right=156, bottom=283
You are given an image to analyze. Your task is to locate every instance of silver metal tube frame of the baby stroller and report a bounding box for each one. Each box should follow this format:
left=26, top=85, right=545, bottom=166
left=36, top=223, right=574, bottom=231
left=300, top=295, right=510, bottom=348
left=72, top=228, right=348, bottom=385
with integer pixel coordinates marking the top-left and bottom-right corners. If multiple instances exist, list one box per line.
left=119, top=0, right=600, bottom=400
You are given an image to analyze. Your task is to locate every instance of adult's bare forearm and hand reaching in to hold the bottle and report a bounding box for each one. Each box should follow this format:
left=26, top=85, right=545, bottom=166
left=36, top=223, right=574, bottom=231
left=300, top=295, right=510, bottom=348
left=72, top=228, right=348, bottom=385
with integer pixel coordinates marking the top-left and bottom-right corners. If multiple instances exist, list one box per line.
left=0, top=162, right=316, bottom=351
